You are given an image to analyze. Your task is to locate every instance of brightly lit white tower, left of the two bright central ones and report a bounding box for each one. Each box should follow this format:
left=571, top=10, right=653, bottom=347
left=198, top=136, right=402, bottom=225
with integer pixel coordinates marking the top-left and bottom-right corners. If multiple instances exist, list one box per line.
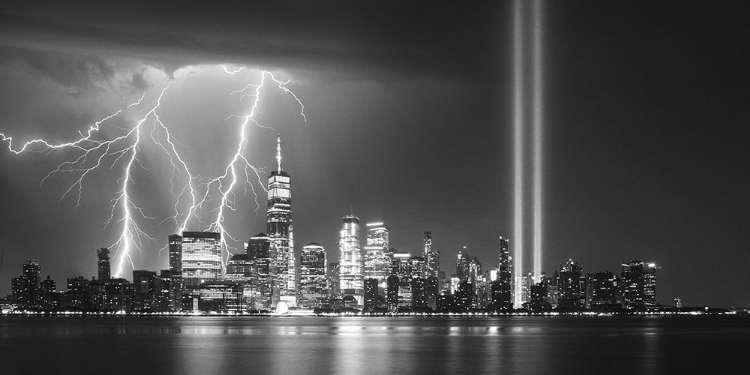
left=339, top=215, right=364, bottom=307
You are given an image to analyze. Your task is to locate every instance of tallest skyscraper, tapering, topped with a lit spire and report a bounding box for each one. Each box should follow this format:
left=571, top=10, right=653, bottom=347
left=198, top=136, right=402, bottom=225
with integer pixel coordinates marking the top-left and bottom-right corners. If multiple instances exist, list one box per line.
left=266, top=136, right=297, bottom=305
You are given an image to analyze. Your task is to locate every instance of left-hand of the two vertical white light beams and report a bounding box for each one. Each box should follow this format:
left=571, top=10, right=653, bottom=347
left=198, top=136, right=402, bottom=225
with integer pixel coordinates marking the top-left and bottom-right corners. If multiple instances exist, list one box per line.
left=513, top=0, right=524, bottom=308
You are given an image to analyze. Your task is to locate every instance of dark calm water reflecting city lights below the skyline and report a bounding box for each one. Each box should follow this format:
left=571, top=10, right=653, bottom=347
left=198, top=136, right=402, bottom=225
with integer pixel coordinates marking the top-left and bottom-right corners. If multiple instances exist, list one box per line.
left=0, top=316, right=750, bottom=375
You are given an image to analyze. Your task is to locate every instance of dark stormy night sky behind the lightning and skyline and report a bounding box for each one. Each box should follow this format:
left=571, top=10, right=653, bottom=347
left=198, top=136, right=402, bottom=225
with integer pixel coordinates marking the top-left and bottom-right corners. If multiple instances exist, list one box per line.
left=0, top=1, right=750, bottom=306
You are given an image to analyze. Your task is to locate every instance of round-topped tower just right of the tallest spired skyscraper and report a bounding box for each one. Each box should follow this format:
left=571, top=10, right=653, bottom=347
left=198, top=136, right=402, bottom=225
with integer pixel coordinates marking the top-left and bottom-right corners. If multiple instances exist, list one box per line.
left=299, top=242, right=328, bottom=309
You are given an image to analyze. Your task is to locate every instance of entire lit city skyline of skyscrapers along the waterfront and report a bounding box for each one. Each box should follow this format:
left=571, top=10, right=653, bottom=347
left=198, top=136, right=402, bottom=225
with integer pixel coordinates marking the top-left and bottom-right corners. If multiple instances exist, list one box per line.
left=4, top=140, right=656, bottom=313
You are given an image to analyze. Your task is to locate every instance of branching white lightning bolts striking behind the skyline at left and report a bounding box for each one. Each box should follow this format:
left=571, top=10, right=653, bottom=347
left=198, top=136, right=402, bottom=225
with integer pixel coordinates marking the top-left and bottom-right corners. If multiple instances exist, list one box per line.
left=0, top=65, right=307, bottom=277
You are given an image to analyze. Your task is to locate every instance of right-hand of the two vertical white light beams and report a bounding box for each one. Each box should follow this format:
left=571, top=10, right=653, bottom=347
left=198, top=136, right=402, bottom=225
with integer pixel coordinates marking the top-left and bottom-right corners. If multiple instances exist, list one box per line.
left=532, top=0, right=543, bottom=282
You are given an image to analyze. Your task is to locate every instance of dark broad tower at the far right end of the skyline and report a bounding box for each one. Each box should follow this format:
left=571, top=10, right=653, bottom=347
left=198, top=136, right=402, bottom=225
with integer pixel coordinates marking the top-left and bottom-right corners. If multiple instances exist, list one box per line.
left=620, top=260, right=657, bottom=309
